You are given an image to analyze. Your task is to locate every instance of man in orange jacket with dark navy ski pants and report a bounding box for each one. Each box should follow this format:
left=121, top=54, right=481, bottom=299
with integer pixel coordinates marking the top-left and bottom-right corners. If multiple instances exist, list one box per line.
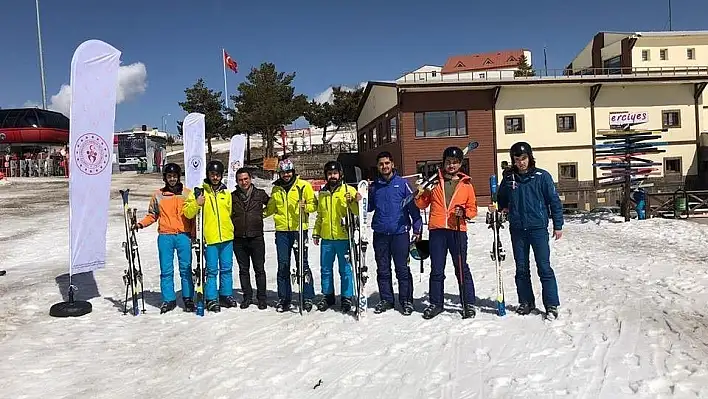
left=415, top=147, right=477, bottom=319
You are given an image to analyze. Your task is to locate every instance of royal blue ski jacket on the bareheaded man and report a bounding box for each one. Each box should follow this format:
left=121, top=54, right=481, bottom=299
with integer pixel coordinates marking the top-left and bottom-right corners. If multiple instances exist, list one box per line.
left=367, top=171, right=423, bottom=235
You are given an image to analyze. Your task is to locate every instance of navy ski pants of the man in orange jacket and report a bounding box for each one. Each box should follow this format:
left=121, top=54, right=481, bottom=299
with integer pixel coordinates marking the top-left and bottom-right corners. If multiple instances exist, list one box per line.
left=428, top=229, right=476, bottom=307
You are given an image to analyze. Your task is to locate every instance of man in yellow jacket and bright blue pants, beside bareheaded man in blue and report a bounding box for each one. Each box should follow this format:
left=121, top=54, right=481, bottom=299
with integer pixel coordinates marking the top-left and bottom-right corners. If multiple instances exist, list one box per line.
left=312, top=161, right=361, bottom=313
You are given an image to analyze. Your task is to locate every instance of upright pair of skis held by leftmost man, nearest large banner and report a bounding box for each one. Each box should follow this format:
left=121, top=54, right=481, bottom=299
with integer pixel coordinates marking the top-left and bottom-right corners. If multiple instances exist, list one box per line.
left=120, top=189, right=145, bottom=316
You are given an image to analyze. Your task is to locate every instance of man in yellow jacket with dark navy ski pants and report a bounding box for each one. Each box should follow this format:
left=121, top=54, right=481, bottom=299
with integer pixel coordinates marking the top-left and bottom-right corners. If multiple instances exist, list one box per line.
left=263, top=159, right=317, bottom=312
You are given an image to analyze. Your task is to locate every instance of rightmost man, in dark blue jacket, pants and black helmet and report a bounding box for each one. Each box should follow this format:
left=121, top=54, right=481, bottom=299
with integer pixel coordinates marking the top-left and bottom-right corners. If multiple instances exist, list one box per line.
left=489, top=142, right=563, bottom=318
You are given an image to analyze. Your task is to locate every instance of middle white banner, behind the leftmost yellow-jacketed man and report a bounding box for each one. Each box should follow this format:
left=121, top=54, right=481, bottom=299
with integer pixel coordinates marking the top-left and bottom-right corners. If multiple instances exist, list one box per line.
left=182, top=112, right=206, bottom=190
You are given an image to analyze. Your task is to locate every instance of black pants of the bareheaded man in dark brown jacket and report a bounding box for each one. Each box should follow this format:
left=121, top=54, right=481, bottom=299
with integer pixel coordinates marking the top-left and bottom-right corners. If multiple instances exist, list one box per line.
left=234, top=236, right=266, bottom=301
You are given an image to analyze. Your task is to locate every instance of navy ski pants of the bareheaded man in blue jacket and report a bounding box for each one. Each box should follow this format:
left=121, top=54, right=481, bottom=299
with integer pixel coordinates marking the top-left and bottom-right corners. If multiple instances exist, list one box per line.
left=373, top=233, right=413, bottom=304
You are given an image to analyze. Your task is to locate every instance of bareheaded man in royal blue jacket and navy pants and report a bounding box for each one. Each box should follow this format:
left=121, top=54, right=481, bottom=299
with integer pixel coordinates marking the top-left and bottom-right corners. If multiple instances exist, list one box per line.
left=367, top=151, right=423, bottom=316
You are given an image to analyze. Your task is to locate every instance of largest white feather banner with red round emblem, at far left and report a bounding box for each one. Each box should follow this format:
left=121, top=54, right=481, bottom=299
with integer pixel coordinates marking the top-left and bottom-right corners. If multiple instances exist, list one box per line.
left=67, top=40, right=121, bottom=275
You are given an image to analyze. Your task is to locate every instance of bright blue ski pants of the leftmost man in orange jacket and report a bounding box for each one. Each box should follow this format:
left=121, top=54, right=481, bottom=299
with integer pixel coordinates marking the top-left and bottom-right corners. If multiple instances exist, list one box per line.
left=157, top=233, right=194, bottom=302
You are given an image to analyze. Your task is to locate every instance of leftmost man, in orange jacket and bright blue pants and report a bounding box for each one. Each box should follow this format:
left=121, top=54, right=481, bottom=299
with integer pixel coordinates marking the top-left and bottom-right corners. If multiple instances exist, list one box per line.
left=133, top=163, right=194, bottom=314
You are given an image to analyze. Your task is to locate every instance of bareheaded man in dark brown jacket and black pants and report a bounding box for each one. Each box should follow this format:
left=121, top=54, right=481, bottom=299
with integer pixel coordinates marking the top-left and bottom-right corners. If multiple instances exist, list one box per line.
left=231, top=168, right=270, bottom=310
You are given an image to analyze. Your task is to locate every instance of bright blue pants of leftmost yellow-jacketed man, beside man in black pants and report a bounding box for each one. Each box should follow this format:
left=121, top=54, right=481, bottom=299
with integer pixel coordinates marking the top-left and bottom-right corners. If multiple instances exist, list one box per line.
left=204, top=241, right=234, bottom=301
